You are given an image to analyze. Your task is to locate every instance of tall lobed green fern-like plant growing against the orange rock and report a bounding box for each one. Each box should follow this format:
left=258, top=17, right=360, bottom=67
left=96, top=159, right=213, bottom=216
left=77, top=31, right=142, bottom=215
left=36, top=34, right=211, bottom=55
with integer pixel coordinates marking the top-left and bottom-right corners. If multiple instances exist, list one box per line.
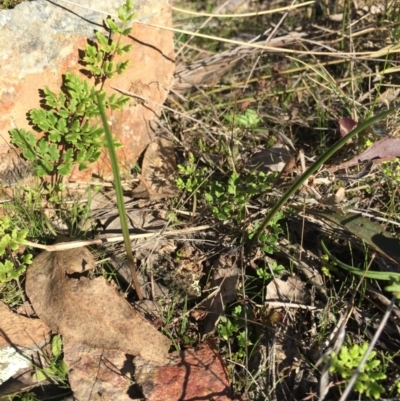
left=10, top=0, right=135, bottom=177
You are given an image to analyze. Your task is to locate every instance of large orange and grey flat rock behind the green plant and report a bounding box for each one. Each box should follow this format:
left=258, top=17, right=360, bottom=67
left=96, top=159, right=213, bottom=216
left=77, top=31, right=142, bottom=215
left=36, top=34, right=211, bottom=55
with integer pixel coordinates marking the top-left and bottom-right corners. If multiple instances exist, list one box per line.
left=0, top=0, right=175, bottom=181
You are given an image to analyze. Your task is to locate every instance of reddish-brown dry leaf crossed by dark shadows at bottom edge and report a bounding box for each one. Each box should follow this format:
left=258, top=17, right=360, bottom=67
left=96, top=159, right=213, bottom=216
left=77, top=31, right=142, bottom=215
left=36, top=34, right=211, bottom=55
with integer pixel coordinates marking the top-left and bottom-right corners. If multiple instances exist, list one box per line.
left=134, top=344, right=232, bottom=401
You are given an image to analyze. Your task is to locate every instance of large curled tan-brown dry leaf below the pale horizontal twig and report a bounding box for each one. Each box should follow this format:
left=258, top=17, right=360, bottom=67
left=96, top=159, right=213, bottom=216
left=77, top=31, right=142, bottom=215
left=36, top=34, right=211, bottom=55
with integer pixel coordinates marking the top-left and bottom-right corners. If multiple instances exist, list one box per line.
left=26, top=248, right=171, bottom=362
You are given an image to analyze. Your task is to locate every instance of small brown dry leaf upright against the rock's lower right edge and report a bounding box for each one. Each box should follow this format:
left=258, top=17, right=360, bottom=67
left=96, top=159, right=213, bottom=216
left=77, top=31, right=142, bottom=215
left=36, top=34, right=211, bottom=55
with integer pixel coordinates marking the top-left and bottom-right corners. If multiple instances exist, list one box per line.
left=132, top=138, right=176, bottom=200
